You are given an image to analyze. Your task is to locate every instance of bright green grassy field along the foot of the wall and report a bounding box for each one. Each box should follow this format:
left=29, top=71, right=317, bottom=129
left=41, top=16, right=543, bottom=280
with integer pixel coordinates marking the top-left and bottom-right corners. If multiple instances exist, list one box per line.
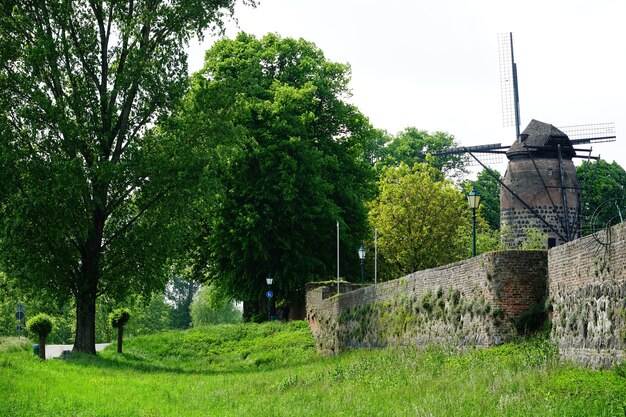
left=0, top=322, right=626, bottom=417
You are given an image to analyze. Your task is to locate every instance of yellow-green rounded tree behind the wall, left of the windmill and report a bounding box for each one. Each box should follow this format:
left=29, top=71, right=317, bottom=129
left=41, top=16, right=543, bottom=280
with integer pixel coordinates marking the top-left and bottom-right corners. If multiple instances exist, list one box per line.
left=370, top=164, right=470, bottom=277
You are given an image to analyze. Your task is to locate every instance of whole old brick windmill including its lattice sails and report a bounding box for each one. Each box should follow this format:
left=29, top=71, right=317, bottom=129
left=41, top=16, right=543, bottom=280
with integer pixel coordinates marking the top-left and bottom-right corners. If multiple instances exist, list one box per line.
left=434, top=33, right=615, bottom=247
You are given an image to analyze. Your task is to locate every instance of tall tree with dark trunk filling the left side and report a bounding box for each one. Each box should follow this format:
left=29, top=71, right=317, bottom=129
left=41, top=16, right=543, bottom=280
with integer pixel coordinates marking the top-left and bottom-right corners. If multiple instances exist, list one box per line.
left=0, top=0, right=244, bottom=354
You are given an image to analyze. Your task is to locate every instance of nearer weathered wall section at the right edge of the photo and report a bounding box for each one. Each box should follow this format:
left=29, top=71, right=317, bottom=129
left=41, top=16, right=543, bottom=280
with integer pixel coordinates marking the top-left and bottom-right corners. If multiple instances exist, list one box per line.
left=548, top=224, right=626, bottom=367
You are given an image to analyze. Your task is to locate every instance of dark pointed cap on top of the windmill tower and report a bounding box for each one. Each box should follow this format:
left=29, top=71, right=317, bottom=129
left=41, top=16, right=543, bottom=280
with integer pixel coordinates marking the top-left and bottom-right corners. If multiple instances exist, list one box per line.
left=506, top=119, right=576, bottom=159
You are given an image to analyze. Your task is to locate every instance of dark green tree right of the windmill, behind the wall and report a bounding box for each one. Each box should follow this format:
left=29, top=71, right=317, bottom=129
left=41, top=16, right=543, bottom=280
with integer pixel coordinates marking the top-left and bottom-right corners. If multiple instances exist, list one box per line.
left=576, top=159, right=626, bottom=235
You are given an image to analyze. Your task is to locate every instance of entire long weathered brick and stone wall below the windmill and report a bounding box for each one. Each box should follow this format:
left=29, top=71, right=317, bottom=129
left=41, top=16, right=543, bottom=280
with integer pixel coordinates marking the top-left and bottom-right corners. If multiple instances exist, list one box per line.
left=307, top=223, right=626, bottom=368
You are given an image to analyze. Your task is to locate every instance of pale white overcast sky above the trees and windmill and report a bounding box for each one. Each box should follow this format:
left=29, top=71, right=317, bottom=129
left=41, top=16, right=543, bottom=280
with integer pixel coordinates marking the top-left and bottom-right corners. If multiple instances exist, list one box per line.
left=189, top=0, right=626, bottom=176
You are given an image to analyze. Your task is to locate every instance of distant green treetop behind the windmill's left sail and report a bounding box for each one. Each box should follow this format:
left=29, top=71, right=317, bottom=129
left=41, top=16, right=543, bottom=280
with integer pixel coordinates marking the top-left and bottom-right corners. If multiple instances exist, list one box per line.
left=372, top=127, right=468, bottom=179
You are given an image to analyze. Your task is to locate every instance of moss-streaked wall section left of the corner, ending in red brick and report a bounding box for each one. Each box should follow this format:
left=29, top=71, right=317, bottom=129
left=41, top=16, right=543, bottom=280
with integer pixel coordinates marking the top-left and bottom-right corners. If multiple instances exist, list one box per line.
left=307, top=251, right=547, bottom=352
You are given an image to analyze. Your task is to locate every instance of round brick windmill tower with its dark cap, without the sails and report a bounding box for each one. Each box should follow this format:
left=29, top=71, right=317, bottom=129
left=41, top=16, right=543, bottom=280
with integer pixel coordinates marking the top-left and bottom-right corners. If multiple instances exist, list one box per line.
left=500, top=120, right=581, bottom=247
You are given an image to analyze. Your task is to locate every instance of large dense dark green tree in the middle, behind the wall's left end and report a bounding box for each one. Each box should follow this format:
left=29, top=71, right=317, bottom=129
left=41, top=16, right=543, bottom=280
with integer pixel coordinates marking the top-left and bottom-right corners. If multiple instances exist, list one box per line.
left=184, top=33, right=374, bottom=314
